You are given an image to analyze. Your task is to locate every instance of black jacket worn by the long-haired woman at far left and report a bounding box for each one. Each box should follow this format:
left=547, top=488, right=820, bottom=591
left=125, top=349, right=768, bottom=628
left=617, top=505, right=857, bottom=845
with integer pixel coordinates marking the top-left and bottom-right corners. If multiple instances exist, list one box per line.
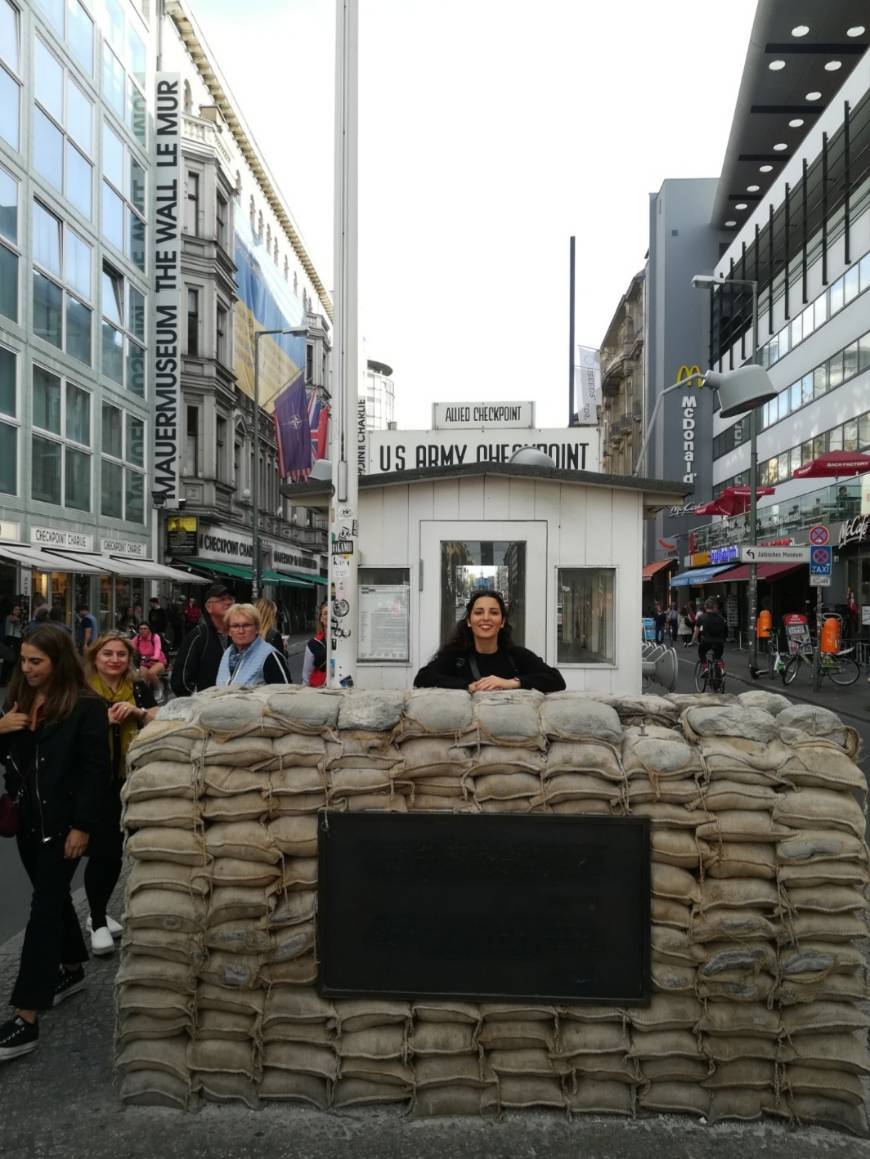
left=0, top=693, right=109, bottom=840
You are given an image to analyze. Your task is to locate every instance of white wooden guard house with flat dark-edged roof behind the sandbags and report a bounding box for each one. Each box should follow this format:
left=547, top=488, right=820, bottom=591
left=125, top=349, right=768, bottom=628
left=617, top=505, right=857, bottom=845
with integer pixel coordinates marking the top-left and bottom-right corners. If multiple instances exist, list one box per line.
left=284, top=462, right=689, bottom=694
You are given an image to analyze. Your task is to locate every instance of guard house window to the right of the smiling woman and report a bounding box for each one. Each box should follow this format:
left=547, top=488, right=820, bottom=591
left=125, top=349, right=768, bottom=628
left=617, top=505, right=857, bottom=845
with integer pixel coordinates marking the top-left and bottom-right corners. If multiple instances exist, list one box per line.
left=556, top=568, right=616, bottom=664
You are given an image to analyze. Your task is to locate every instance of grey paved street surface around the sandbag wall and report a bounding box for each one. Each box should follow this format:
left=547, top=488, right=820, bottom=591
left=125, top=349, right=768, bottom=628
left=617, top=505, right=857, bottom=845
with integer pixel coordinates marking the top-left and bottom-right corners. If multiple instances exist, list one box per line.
left=0, top=642, right=870, bottom=1159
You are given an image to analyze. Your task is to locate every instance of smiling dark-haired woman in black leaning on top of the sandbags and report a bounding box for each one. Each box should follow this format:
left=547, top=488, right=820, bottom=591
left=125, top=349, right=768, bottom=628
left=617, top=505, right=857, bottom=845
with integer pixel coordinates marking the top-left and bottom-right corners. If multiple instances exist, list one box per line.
left=414, top=590, right=565, bottom=692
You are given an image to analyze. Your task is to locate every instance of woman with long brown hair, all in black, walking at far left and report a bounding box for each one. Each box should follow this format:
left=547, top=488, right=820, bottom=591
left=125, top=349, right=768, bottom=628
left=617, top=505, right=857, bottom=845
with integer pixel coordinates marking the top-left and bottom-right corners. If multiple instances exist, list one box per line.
left=0, top=625, right=109, bottom=1060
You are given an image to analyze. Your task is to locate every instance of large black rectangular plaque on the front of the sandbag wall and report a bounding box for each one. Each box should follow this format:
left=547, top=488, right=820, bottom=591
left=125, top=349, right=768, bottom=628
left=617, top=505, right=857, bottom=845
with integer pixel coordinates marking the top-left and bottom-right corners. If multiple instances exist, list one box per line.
left=317, top=812, right=650, bottom=1004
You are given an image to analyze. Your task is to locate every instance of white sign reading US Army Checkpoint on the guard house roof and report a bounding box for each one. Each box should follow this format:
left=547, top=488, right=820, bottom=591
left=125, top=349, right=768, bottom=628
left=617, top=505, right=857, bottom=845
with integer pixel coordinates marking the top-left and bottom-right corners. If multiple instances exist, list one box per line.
left=365, top=427, right=600, bottom=475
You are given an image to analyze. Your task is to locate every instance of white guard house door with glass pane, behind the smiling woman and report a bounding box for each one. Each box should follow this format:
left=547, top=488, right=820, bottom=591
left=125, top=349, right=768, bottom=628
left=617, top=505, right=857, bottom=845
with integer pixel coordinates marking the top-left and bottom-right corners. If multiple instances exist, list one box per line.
left=417, top=519, right=547, bottom=664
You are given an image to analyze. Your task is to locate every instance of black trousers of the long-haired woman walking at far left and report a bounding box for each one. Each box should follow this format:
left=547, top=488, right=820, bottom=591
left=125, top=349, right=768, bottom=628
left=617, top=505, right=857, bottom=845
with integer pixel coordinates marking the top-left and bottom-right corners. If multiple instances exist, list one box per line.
left=10, top=833, right=88, bottom=1011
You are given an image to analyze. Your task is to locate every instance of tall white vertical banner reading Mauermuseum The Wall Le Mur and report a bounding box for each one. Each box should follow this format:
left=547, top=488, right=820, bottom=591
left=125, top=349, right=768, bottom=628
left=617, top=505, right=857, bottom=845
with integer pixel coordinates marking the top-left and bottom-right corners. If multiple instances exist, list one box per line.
left=152, top=73, right=182, bottom=508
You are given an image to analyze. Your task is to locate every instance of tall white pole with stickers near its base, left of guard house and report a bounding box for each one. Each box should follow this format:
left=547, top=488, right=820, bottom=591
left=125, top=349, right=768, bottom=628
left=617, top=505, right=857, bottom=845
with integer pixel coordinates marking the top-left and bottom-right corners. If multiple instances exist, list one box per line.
left=327, top=0, right=359, bottom=688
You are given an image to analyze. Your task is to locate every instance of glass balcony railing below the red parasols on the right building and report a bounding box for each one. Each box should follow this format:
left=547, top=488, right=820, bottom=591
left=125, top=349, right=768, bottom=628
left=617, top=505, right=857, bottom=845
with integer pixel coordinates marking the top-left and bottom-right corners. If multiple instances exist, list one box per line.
left=688, top=476, right=861, bottom=552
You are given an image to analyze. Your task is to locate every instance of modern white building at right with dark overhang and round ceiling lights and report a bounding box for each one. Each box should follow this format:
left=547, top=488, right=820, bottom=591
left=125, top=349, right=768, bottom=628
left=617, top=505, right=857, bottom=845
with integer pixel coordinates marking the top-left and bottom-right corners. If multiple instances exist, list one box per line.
left=695, top=3, right=870, bottom=627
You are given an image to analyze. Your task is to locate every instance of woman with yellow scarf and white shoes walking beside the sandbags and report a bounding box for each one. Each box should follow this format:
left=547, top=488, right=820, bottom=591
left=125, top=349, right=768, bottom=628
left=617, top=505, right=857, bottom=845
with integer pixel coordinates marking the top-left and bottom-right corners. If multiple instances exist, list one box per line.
left=85, top=632, right=158, bottom=955
